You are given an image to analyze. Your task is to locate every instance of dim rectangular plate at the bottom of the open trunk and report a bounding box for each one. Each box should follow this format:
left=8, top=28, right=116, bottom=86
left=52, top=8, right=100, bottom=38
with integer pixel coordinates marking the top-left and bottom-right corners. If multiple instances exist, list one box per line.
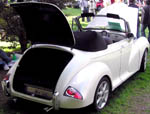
left=25, top=84, right=53, bottom=99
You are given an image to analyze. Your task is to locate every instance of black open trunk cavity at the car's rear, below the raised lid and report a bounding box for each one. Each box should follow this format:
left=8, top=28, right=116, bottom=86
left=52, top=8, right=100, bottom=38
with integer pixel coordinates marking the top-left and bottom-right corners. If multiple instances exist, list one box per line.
left=13, top=48, right=73, bottom=99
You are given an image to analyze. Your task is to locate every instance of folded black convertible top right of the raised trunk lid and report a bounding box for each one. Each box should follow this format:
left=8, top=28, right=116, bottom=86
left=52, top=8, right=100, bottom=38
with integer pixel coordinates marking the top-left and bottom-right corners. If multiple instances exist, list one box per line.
left=74, top=31, right=107, bottom=51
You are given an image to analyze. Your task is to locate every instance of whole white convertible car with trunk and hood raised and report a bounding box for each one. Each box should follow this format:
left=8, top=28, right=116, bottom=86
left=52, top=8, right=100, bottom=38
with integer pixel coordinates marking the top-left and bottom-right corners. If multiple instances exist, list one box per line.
left=2, top=2, right=149, bottom=111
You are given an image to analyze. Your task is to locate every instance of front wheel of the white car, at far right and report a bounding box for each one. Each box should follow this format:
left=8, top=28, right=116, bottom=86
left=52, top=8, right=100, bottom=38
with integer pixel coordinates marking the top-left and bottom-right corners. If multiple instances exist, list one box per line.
left=140, top=50, right=148, bottom=72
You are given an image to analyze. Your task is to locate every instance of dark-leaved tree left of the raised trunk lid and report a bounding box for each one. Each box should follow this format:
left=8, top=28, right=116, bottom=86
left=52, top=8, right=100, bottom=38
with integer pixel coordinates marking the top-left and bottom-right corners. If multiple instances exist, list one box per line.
left=0, top=1, right=27, bottom=52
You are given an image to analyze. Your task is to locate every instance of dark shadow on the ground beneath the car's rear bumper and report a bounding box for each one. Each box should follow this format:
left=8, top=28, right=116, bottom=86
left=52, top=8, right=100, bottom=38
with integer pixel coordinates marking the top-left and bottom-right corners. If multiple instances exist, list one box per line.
left=0, top=99, right=93, bottom=114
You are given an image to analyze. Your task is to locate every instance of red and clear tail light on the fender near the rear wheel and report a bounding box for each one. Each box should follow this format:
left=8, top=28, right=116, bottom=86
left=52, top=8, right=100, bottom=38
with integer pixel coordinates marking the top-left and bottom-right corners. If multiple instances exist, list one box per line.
left=64, top=86, right=83, bottom=100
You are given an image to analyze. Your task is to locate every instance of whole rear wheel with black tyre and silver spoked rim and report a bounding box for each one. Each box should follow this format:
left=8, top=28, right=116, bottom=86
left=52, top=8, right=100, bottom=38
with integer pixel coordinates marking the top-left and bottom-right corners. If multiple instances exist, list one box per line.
left=93, top=77, right=110, bottom=111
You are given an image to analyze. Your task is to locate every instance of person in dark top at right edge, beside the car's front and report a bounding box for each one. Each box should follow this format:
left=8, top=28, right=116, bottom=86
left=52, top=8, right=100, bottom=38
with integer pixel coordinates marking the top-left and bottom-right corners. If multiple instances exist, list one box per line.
left=141, top=0, right=150, bottom=42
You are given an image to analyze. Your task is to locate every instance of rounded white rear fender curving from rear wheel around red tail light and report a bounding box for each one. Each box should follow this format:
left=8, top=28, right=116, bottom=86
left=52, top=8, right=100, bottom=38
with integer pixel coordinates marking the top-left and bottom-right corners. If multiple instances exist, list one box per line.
left=56, top=63, right=109, bottom=108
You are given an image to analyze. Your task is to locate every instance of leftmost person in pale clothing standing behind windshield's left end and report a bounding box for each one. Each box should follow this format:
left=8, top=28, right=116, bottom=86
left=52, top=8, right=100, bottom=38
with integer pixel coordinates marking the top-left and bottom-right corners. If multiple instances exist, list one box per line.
left=80, top=0, right=90, bottom=22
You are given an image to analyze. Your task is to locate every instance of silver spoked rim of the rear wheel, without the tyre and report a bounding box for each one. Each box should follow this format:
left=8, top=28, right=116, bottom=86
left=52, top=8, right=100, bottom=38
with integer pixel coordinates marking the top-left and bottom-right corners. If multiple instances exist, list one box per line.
left=96, top=81, right=109, bottom=109
